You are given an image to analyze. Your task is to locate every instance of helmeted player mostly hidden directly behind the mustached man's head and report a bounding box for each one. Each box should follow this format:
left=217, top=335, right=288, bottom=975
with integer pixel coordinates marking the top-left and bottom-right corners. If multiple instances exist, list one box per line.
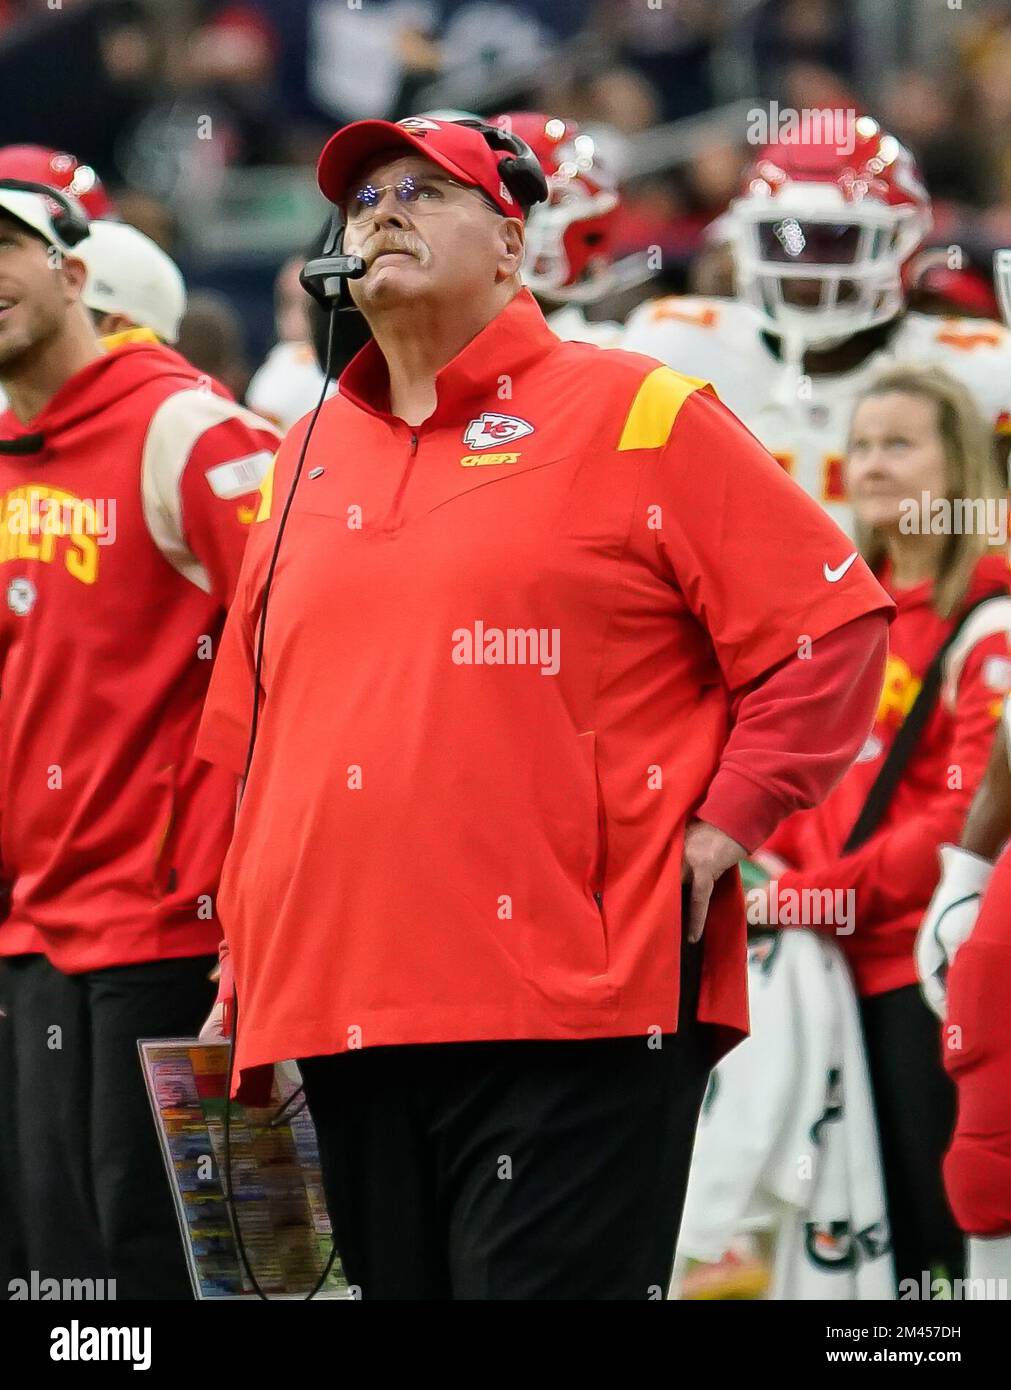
left=491, top=111, right=649, bottom=348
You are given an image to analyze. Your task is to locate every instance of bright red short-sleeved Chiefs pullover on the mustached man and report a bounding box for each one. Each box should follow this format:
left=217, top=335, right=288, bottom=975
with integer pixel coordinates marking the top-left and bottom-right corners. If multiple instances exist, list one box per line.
left=197, top=291, right=889, bottom=1072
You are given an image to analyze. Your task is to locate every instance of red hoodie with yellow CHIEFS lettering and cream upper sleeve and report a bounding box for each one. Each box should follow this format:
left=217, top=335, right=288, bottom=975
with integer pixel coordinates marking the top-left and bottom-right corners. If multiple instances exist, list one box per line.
left=0, top=342, right=278, bottom=974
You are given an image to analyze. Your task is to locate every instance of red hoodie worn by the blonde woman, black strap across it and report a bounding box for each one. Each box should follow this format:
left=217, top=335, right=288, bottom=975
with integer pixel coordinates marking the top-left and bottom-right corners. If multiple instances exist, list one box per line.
left=763, top=555, right=1011, bottom=995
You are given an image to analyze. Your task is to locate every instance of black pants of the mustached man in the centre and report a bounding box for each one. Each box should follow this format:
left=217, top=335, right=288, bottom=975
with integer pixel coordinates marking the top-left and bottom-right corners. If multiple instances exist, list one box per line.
left=299, top=944, right=711, bottom=1300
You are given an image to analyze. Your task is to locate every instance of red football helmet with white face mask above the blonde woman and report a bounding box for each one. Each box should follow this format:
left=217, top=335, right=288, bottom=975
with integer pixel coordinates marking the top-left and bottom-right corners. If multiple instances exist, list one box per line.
left=727, top=111, right=932, bottom=352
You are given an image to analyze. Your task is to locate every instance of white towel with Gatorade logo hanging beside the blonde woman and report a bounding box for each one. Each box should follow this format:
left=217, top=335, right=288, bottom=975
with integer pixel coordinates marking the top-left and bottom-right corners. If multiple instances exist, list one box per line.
left=677, top=930, right=896, bottom=1300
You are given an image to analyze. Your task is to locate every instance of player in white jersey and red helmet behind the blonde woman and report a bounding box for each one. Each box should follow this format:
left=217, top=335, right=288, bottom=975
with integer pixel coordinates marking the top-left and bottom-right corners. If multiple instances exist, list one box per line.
left=620, top=117, right=1011, bottom=532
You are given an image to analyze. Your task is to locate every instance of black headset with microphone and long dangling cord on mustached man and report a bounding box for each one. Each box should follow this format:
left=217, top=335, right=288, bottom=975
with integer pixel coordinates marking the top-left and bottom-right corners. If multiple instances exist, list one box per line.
left=226, top=117, right=548, bottom=1302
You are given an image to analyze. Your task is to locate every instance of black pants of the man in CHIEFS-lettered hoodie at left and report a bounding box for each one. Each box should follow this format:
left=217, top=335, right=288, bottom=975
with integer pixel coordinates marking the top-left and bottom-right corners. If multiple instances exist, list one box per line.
left=6, top=955, right=216, bottom=1298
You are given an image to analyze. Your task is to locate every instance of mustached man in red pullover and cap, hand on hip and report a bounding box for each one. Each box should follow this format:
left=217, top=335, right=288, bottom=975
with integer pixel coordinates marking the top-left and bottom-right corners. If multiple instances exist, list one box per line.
left=199, top=117, right=890, bottom=1298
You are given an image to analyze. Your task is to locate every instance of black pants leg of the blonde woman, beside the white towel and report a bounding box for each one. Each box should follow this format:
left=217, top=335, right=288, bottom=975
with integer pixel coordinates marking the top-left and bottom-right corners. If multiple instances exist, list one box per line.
left=861, top=984, right=965, bottom=1287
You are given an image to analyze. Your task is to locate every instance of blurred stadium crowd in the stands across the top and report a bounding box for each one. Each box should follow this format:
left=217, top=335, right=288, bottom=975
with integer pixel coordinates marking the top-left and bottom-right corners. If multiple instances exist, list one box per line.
left=0, top=0, right=1011, bottom=384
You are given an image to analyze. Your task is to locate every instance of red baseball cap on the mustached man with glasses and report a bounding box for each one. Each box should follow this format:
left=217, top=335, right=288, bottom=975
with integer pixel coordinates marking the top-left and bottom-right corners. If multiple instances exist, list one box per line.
left=316, top=115, right=523, bottom=217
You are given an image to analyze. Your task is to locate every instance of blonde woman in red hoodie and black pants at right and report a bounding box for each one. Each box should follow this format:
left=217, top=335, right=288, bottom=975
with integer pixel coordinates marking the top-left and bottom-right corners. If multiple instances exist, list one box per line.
left=765, top=366, right=1011, bottom=1297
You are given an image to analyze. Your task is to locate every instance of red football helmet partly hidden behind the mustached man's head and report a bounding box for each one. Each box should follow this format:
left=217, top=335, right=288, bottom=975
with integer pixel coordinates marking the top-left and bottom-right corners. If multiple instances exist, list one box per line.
left=491, top=111, right=619, bottom=304
